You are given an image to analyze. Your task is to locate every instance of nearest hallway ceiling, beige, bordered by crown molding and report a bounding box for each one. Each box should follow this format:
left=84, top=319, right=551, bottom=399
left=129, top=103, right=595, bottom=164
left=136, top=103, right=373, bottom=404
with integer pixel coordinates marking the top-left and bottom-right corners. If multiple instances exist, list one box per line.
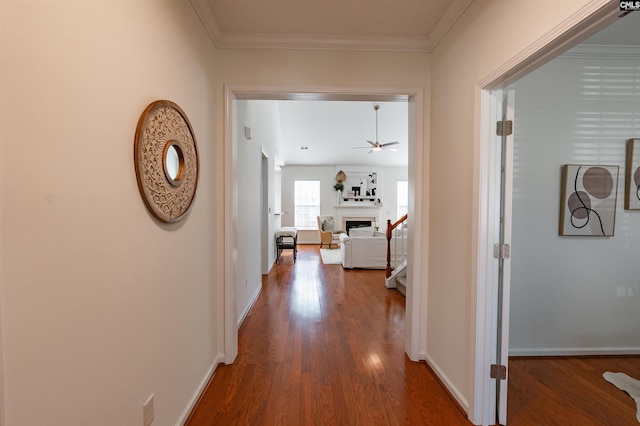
left=190, top=0, right=472, bottom=52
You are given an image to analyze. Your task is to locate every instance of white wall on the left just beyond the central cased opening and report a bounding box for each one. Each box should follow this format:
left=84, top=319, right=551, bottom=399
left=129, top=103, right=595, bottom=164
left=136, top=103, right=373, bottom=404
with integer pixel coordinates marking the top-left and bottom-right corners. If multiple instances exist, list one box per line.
left=235, top=100, right=280, bottom=325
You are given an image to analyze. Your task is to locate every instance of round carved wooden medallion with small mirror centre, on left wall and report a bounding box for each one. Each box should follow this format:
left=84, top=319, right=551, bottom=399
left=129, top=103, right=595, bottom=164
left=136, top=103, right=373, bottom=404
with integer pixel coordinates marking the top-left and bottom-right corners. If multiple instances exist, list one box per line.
left=134, top=100, right=199, bottom=222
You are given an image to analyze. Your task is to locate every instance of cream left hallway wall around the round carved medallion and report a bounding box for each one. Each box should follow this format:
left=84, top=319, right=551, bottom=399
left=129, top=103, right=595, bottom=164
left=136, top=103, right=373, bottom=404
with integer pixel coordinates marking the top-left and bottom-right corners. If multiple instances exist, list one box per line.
left=0, top=0, right=222, bottom=425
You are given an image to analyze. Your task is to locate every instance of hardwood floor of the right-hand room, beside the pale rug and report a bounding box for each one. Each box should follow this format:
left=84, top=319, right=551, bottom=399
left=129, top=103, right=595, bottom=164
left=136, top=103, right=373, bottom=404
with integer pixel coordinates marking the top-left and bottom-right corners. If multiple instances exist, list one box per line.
left=507, top=357, right=640, bottom=426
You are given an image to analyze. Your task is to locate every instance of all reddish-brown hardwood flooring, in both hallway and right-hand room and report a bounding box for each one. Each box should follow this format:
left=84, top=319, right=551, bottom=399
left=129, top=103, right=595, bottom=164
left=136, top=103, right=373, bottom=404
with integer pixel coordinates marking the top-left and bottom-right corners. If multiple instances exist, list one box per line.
left=181, top=245, right=640, bottom=426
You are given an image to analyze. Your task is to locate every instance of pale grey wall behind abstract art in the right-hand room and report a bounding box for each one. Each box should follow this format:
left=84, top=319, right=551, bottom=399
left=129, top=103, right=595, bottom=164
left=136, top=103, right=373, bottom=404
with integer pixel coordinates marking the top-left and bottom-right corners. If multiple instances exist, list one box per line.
left=510, top=49, right=640, bottom=355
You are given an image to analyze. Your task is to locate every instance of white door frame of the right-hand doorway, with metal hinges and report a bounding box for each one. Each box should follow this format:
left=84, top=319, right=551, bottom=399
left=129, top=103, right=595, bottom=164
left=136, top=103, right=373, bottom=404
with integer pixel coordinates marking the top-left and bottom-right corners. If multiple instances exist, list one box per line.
left=469, top=0, right=621, bottom=425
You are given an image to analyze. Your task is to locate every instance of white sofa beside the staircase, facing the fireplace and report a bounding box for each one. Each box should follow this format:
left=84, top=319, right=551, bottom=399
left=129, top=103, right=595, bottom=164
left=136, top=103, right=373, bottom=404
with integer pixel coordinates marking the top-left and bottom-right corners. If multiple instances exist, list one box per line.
left=340, top=227, right=407, bottom=269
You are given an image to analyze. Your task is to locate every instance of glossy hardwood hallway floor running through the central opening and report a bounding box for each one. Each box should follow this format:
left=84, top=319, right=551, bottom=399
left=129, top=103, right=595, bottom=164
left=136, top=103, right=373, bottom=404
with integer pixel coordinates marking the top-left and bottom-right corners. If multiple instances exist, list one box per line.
left=187, top=245, right=471, bottom=425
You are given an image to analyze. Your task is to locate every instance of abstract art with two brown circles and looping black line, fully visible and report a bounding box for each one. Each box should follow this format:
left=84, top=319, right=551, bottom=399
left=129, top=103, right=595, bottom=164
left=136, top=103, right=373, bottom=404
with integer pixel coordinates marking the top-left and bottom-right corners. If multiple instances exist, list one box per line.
left=560, top=164, right=619, bottom=237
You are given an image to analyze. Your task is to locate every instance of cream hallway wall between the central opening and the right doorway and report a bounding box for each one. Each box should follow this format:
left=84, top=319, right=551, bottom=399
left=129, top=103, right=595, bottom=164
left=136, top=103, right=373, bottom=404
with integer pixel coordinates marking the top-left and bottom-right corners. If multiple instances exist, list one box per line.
left=430, top=0, right=603, bottom=412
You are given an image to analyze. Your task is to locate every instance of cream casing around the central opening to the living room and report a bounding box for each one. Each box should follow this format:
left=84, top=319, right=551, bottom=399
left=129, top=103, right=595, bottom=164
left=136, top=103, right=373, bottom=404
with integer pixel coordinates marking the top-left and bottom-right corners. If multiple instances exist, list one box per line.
left=221, top=85, right=428, bottom=364
